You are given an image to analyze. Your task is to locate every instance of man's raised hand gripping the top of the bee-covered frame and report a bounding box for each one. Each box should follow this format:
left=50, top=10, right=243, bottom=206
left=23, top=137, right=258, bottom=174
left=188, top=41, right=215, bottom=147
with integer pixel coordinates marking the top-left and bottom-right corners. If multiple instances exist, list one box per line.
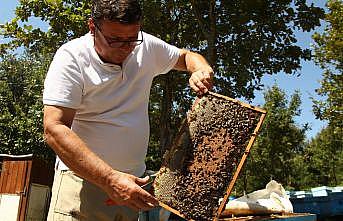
left=189, top=67, right=213, bottom=95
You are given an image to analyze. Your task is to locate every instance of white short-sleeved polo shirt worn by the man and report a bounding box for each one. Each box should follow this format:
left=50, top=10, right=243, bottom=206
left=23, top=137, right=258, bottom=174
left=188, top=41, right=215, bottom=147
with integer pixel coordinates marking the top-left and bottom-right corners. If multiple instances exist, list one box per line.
left=43, top=33, right=180, bottom=176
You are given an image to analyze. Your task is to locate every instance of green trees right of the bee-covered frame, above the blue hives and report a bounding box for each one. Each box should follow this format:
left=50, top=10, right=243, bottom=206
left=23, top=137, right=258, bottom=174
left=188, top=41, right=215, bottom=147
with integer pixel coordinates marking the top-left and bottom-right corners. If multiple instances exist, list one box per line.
left=236, top=81, right=343, bottom=194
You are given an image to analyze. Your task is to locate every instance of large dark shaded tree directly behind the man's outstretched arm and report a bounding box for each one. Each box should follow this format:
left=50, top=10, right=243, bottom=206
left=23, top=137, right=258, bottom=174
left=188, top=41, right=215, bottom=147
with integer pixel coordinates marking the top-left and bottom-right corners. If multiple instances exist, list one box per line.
left=140, top=0, right=323, bottom=159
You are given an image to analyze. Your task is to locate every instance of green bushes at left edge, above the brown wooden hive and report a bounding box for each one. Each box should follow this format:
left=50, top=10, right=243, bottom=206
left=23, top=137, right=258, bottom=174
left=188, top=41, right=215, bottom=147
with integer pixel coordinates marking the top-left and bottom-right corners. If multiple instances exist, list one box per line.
left=0, top=51, right=53, bottom=159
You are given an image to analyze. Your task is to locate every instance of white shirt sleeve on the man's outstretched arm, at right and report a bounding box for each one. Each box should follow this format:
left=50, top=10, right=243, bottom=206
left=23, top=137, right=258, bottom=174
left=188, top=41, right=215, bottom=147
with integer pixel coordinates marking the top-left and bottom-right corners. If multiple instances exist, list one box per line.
left=148, top=35, right=180, bottom=76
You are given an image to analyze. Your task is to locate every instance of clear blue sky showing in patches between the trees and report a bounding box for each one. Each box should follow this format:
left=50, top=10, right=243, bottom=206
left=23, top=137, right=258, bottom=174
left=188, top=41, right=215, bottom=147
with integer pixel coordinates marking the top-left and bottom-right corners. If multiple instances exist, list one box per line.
left=0, top=0, right=326, bottom=139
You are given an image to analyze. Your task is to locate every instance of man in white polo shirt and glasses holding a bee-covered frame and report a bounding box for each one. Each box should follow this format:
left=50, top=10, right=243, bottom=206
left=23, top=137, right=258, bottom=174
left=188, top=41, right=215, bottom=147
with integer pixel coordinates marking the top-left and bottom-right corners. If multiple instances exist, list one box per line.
left=43, top=0, right=213, bottom=221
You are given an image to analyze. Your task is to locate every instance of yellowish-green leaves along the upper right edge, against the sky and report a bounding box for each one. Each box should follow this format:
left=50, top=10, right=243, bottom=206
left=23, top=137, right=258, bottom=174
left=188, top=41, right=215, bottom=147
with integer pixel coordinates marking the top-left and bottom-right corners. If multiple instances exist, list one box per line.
left=313, top=0, right=343, bottom=130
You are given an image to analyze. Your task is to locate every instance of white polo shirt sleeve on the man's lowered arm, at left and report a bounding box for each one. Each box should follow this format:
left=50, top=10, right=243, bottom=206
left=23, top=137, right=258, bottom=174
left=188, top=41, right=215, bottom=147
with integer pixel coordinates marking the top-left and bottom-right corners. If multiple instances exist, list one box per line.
left=43, top=46, right=83, bottom=109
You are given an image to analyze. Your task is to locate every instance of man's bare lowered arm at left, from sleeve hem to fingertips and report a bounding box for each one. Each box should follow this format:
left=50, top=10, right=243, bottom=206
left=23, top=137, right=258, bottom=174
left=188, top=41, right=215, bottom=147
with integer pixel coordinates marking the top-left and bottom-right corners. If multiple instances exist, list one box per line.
left=44, top=105, right=158, bottom=210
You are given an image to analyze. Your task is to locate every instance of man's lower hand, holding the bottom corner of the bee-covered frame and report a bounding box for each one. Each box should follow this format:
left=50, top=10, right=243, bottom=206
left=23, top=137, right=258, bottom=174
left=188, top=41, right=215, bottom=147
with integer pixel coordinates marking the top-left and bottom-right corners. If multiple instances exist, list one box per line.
left=106, top=171, right=158, bottom=211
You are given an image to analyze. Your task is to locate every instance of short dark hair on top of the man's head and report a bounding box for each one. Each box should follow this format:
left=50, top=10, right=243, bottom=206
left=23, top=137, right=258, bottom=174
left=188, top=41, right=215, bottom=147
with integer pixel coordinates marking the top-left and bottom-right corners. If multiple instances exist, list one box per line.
left=92, top=0, right=142, bottom=24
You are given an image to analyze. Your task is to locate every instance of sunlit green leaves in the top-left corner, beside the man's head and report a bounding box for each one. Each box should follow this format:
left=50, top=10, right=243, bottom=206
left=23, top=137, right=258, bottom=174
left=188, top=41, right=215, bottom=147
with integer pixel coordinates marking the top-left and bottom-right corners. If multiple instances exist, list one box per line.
left=0, top=0, right=90, bottom=54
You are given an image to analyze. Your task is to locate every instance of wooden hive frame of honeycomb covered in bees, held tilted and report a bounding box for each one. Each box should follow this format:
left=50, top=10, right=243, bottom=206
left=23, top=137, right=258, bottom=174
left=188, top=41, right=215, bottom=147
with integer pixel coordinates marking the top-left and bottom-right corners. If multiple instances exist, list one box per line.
left=154, top=92, right=266, bottom=221
